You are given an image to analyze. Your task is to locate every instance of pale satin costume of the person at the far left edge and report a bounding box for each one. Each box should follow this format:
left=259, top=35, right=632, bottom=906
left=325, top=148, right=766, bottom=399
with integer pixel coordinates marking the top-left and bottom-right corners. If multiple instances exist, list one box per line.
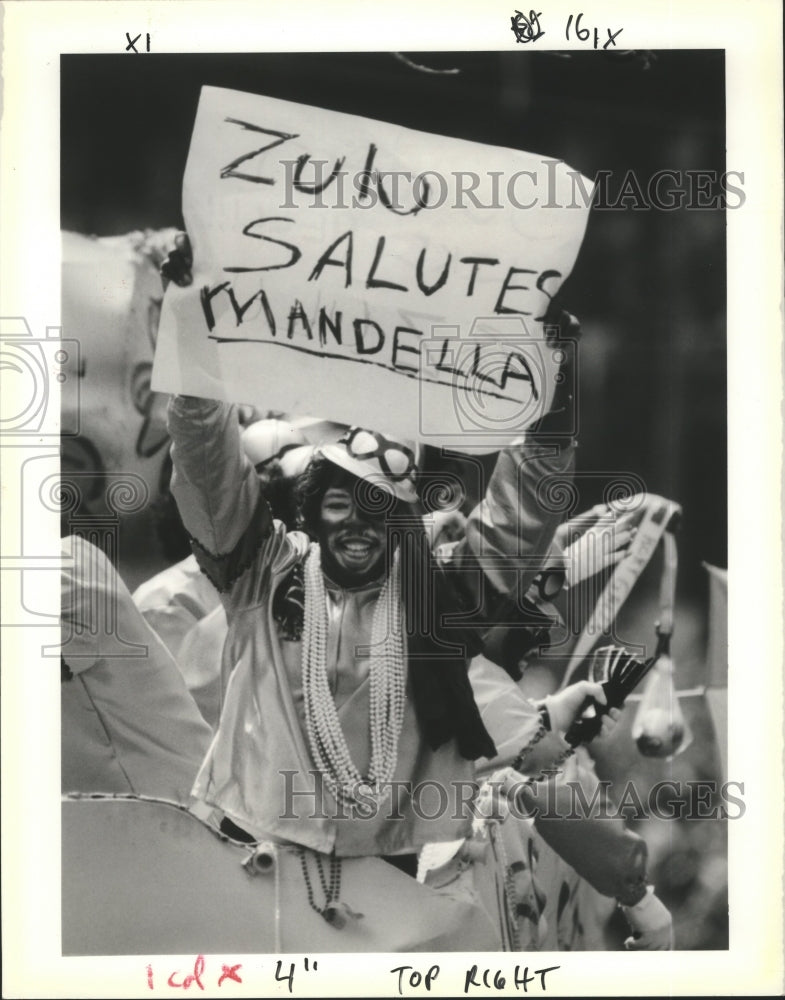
left=60, top=535, right=212, bottom=806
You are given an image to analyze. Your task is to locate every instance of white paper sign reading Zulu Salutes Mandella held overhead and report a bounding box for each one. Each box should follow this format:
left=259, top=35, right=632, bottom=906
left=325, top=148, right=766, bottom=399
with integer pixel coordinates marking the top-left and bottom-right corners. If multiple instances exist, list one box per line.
left=153, top=87, right=591, bottom=448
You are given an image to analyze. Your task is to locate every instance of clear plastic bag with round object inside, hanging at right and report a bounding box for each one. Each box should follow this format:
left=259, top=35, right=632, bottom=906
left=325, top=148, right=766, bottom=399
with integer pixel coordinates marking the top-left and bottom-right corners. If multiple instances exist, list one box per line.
left=632, top=653, right=692, bottom=759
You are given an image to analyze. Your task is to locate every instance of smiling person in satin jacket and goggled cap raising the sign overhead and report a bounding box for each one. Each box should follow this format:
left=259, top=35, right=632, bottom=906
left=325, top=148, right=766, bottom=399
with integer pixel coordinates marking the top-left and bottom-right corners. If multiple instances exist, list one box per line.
left=163, top=239, right=614, bottom=884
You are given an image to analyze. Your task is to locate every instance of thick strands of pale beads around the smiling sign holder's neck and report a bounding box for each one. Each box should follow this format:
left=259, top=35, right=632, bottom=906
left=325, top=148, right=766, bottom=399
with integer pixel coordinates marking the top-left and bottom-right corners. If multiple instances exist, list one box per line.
left=302, top=543, right=406, bottom=805
